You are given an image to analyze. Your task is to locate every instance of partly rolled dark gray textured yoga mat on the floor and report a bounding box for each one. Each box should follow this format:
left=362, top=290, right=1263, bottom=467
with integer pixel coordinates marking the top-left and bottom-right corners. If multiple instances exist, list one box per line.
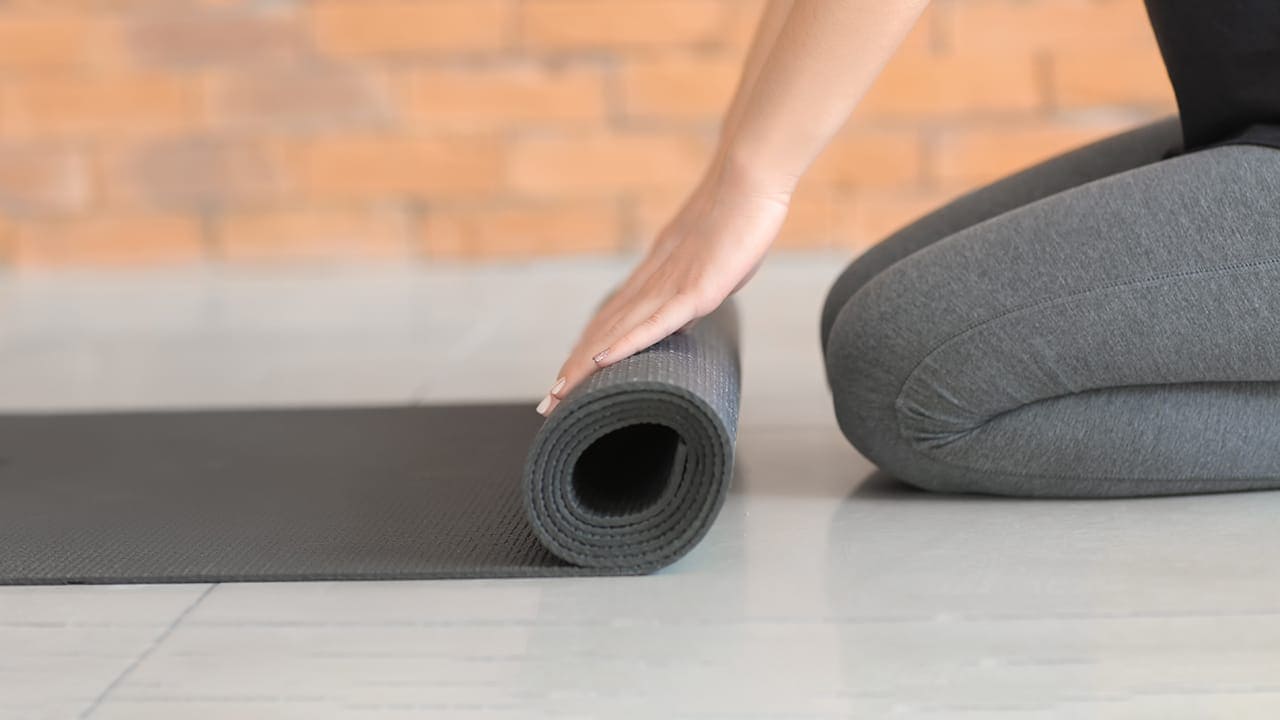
left=0, top=304, right=739, bottom=584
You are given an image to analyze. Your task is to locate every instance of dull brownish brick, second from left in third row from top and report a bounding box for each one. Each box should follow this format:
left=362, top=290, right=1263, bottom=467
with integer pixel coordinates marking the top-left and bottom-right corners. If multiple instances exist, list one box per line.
left=102, top=138, right=287, bottom=209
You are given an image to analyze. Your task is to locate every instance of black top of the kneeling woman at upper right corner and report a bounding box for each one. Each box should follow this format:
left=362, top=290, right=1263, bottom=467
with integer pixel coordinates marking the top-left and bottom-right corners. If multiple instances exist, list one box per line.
left=1146, top=0, right=1280, bottom=150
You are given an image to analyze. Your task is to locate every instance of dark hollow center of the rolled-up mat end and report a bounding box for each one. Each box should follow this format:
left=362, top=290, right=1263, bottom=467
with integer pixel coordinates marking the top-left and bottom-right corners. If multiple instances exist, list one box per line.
left=571, top=424, right=685, bottom=515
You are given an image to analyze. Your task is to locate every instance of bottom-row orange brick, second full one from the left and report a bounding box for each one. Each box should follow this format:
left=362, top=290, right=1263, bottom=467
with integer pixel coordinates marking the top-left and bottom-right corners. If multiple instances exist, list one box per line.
left=215, top=209, right=411, bottom=261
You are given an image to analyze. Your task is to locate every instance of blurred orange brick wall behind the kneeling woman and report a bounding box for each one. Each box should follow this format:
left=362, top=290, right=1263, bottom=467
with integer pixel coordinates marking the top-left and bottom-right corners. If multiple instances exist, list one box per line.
left=0, top=0, right=1172, bottom=266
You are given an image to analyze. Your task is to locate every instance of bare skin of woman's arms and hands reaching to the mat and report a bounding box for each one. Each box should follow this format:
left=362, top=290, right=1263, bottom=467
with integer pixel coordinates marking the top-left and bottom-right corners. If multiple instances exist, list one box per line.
left=538, top=0, right=928, bottom=415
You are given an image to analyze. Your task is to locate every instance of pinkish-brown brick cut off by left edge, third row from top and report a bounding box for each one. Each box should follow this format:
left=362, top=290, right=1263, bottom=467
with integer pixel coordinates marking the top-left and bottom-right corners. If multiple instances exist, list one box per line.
left=0, top=145, right=92, bottom=214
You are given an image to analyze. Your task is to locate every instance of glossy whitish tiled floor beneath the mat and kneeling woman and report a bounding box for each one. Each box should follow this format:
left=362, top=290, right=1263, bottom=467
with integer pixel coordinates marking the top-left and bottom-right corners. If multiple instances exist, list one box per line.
left=0, top=255, right=1280, bottom=720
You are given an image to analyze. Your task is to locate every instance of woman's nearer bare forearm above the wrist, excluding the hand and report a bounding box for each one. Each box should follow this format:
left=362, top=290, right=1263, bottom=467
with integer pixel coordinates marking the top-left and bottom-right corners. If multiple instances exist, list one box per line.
left=718, top=0, right=928, bottom=193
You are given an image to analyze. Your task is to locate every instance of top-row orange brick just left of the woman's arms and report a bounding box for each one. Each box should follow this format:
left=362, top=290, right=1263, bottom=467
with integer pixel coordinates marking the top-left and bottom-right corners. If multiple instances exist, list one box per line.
left=521, top=0, right=732, bottom=50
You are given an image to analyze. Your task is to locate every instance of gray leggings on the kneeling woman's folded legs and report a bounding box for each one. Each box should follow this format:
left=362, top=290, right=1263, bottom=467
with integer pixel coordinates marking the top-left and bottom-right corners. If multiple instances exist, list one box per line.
left=822, top=119, right=1280, bottom=497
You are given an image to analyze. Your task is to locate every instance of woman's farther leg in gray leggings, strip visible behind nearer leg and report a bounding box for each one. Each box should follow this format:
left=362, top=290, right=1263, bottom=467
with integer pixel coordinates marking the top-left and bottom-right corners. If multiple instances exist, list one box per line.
left=822, top=118, right=1181, bottom=348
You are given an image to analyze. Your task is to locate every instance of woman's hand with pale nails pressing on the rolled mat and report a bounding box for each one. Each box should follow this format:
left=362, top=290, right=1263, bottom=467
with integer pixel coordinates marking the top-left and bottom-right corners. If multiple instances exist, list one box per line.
left=538, top=172, right=791, bottom=415
